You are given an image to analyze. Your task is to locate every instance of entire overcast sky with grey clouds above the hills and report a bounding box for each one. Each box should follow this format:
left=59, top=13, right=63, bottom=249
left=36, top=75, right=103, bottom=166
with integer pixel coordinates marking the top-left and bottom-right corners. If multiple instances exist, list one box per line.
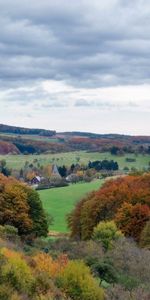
left=0, top=0, right=150, bottom=135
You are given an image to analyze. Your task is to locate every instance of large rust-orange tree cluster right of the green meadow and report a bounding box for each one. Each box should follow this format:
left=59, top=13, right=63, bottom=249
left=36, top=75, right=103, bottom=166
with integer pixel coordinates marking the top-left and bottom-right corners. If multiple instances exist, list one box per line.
left=68, top=174, right=150, bottom=242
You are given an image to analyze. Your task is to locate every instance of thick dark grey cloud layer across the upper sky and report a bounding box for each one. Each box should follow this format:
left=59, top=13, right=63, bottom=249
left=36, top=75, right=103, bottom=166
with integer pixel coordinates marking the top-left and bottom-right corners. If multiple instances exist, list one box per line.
left=0, top=0, right=150, bottom=88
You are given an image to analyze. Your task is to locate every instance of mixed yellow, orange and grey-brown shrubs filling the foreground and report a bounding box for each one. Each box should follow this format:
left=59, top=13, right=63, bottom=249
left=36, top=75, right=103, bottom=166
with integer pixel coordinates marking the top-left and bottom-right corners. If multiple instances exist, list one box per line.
left=0, top=226, right=150, bottom=300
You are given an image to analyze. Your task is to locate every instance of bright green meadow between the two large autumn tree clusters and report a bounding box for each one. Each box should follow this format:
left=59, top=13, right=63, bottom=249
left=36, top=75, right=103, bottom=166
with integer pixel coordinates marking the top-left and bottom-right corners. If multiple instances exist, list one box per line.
left=39, top=180, right=104, bottom=232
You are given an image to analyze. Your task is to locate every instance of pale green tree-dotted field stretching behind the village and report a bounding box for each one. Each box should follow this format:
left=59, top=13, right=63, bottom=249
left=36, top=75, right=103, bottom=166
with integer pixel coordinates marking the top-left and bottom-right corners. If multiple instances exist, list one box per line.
left=0, top=151, right=150, bottom=170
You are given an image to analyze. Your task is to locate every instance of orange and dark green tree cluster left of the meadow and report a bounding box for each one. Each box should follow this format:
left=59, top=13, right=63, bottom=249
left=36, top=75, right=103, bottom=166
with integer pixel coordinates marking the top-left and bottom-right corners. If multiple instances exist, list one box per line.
left=0, top=174, right=48, bottom=237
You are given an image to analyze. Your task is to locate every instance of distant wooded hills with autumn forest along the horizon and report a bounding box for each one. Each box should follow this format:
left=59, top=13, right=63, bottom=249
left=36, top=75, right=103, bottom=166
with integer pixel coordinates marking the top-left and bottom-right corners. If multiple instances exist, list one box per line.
left=0, top=124, right=150, bottom=154
